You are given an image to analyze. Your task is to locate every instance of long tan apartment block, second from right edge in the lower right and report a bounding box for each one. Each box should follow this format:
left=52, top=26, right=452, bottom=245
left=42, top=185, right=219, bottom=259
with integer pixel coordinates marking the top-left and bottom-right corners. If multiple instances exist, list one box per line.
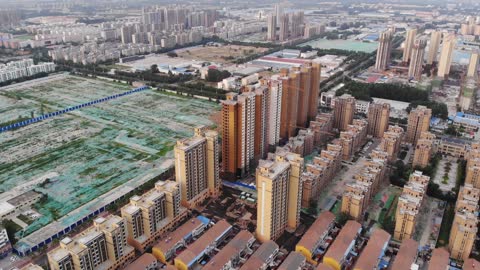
left=394, top=171, right=430, bottom=241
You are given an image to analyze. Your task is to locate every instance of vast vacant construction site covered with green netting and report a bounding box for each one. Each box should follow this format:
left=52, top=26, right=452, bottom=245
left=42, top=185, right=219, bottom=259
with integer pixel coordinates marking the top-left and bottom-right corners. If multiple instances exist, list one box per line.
left=0, top=74, right=220, bottom=243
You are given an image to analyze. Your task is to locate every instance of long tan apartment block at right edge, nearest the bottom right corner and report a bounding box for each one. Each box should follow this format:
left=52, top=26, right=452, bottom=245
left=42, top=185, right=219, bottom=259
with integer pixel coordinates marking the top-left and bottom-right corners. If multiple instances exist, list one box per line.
left=448, top=184, right=480, bottom=261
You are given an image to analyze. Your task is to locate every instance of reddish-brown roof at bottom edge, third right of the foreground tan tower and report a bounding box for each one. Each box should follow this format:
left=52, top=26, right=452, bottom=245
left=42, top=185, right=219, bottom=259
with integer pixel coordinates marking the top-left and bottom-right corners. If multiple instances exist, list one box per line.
left=355, top=229, right=390, bottom=269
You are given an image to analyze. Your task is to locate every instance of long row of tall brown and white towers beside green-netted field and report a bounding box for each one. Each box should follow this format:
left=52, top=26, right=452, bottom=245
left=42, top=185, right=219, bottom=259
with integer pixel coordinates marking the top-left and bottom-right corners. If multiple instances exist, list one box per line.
left=222, top=62, right=321, bottom=179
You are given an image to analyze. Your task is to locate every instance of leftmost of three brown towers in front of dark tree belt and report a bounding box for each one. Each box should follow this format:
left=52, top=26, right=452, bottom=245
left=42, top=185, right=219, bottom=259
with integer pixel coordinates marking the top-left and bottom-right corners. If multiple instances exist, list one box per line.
left=333, top=94, right=355, bottom=131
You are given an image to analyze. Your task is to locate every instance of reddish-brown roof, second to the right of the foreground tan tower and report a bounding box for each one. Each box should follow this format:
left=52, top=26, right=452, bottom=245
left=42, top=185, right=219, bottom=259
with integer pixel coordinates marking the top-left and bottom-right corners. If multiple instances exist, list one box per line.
left=325, top=220, right=362, bottom=262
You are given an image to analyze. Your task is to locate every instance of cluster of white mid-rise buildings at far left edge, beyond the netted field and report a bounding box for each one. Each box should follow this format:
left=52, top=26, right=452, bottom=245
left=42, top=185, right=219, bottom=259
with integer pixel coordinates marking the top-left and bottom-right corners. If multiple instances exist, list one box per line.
left=0, top=59, right=55, bottom=83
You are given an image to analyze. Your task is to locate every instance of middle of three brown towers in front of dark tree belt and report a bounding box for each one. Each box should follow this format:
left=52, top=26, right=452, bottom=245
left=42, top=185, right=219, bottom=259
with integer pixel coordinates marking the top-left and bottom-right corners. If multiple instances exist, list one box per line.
left=367, top=103, right=390, bottom=138
